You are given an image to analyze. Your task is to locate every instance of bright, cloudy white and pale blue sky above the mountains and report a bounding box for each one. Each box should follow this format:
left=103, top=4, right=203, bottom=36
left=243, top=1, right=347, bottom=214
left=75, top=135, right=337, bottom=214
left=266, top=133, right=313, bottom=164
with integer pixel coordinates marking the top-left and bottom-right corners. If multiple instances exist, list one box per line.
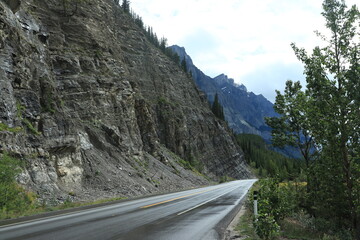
left=130, top=0, right=358, bottom=102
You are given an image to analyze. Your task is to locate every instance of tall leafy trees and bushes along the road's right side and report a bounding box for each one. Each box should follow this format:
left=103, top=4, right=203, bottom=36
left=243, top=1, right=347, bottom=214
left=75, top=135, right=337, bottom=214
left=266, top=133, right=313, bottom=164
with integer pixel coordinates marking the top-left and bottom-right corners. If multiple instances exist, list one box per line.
left=238, top=0, right=360, bottom=240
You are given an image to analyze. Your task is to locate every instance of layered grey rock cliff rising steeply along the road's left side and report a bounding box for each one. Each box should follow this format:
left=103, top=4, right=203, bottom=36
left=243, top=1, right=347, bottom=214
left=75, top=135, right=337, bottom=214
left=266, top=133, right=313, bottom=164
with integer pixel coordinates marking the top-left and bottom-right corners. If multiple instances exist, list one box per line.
left=0, top=0, right=251, bottom=201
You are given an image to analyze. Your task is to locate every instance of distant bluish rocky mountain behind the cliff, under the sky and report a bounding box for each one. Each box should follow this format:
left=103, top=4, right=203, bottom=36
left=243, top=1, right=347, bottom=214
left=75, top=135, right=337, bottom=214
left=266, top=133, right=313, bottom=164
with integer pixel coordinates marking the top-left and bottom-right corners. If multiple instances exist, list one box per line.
left=170, top=45, right=276, bottom=140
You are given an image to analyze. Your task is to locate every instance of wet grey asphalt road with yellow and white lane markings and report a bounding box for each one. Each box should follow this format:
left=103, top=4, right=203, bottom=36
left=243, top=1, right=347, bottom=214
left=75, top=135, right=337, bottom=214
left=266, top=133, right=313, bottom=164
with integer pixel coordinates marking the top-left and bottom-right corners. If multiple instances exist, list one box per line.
left=0, top=180, right=255, bottom=240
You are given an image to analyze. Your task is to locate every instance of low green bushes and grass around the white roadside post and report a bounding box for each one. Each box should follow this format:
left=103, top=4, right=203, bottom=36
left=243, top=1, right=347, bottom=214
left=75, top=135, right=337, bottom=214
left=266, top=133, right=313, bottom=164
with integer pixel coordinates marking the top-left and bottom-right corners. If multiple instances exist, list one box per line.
left=236, top=182, right=328, bottom=240
